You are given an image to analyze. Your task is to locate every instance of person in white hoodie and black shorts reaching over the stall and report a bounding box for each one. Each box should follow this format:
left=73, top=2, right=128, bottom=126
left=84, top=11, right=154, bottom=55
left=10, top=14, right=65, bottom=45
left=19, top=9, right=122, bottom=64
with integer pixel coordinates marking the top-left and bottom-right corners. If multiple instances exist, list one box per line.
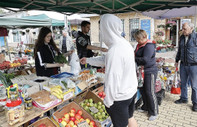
left=80, top=14, right=138, bottom=127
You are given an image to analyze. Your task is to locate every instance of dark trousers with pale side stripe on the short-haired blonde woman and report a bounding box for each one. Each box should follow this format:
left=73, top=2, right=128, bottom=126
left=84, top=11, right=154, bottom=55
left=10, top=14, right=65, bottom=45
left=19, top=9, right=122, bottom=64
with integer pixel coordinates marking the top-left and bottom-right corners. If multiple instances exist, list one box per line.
left=140, top=72, right=158, bottom=115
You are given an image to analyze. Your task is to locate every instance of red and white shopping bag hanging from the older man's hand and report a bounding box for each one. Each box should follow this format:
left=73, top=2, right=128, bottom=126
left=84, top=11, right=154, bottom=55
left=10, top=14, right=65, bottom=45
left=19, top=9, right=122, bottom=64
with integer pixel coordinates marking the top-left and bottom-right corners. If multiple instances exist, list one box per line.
left=171, top=69, right=181, bottom=94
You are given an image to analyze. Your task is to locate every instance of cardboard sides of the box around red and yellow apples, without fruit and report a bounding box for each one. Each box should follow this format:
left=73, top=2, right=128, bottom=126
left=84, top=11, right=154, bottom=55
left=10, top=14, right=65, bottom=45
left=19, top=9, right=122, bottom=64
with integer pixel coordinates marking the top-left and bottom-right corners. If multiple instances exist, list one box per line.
left=52, top=102, right=99, bottom=127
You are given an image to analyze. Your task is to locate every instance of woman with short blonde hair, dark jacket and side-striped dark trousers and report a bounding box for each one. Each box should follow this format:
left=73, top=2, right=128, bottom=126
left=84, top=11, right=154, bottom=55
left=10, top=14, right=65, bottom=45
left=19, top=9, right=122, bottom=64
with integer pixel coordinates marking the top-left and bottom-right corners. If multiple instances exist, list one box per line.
left=134, top=30, right=158, bottom=121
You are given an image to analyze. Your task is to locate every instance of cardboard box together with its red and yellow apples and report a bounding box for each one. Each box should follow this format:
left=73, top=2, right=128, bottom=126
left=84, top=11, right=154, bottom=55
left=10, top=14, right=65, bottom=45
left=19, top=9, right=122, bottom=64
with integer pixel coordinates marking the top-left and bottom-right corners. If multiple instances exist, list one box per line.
left=52, top=102, right=99, bottom=127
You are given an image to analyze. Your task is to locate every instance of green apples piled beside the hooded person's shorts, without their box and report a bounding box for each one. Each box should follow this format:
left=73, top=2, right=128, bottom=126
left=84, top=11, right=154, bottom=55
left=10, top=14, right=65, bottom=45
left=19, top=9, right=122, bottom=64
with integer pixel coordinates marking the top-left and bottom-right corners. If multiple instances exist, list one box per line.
left=80, top=98, right=109, bottom=122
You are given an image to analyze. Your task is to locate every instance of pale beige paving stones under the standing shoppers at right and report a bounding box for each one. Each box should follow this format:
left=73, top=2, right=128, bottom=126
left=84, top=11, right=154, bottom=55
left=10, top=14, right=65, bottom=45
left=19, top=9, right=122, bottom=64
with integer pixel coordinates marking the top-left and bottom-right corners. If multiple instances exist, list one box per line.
left=134, top=88, right=197, bottom=127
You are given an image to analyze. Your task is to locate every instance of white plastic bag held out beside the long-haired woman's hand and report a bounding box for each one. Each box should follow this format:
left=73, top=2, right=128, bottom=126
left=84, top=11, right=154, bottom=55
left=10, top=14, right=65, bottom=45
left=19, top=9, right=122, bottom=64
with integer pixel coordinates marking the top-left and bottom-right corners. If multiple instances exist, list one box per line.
left=69, top=52, right=81, bottom=75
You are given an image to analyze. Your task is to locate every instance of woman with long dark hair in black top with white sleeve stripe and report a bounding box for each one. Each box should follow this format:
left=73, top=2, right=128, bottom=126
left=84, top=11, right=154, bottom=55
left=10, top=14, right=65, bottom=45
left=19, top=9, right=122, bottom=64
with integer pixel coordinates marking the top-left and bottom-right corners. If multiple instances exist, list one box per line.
left=34, top=27, right=63, bottom=77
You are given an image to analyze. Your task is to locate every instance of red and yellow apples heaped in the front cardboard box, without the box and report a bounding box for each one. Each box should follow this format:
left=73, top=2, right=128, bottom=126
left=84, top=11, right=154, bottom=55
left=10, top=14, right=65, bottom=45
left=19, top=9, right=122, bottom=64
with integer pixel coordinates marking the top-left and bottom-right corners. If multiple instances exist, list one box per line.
left=58, top=108, right=97, bottom=127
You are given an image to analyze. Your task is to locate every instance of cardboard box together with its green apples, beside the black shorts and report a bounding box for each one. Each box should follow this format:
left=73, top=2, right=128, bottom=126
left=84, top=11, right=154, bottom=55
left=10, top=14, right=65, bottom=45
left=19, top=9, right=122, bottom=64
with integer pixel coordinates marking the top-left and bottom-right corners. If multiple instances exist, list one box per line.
left=74, top=91, right=112, bottom=127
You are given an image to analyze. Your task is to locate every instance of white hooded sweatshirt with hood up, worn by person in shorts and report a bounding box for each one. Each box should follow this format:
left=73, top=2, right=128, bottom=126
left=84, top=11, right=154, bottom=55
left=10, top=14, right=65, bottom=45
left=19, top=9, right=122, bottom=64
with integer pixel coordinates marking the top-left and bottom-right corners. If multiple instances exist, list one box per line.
left=87, top=14, right=138, bottom=107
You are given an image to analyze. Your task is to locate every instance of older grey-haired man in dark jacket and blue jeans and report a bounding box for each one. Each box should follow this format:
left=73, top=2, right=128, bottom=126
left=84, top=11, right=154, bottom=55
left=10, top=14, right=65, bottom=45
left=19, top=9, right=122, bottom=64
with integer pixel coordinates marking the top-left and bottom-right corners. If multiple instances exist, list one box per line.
left=175, top=23, right=197, bottom=111
